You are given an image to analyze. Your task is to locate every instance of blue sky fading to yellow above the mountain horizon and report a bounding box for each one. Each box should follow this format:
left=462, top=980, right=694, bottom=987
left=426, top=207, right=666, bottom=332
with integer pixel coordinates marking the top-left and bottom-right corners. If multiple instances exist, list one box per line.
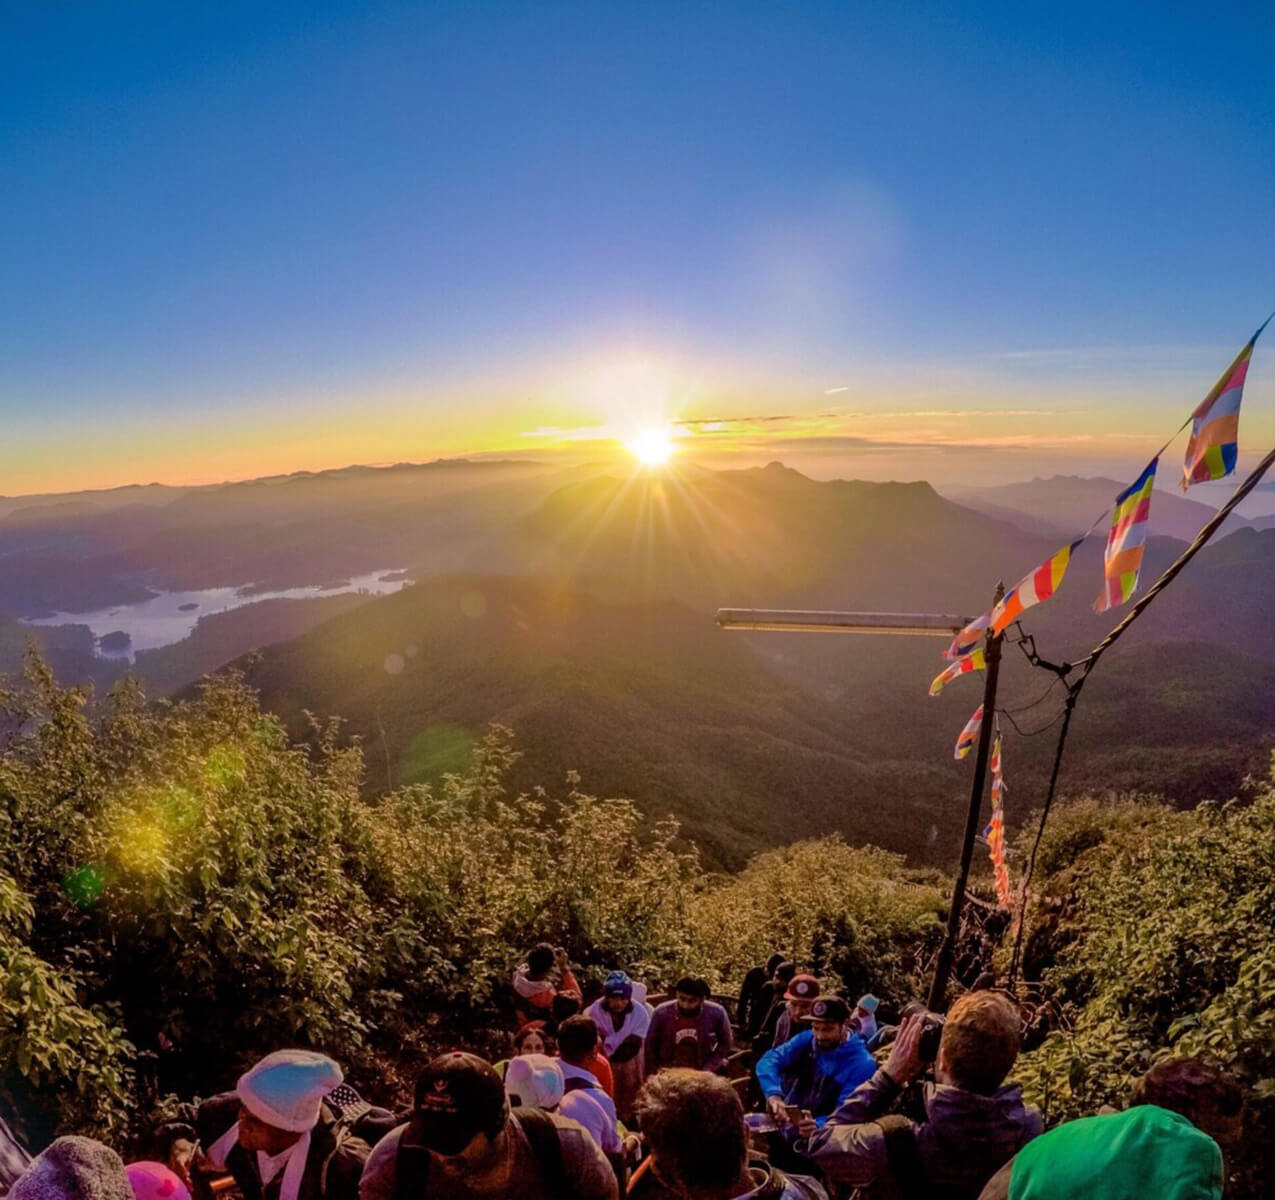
left=0, top=3, right=1275, bottom=494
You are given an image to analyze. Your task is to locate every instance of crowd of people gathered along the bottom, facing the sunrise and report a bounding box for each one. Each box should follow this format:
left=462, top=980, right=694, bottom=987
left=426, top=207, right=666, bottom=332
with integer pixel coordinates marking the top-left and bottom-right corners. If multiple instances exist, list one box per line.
left=0, top=946, right=1243, bottom=1200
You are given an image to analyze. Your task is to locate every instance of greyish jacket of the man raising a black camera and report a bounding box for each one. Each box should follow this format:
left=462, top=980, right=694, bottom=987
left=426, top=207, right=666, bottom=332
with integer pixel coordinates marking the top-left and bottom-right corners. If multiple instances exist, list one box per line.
left=797, top=1071, right=1042, bottom=1200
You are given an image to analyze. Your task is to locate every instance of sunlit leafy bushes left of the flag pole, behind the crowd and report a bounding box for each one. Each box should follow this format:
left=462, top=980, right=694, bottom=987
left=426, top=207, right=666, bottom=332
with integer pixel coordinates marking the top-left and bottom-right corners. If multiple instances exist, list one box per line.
left=0, top=659, right=941, bottom=1140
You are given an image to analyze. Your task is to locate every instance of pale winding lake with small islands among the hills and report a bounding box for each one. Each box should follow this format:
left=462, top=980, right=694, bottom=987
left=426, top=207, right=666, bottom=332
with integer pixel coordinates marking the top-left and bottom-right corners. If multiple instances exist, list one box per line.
left=24, top=567, right=411, bottom=662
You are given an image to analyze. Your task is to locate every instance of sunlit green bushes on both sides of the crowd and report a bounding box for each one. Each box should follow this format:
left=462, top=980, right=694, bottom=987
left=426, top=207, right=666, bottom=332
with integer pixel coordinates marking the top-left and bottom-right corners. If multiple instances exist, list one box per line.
left=0, top=650, right=1275, bottom=1193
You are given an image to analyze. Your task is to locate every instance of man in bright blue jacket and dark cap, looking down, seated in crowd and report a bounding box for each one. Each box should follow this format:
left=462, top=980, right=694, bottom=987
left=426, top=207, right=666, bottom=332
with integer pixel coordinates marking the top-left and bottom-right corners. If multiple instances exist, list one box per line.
left=757, top=996, right=876, bottom=1167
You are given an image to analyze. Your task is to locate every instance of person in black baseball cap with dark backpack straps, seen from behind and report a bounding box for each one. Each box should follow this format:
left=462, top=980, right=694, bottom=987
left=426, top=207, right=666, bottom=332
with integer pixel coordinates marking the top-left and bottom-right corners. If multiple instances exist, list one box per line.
left=360, top=1052, right=620, bottom=1200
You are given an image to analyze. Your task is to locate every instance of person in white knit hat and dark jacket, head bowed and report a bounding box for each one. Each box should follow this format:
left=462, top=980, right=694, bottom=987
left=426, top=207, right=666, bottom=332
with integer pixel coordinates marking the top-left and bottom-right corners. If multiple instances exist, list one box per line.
left=159, top=1050, right=371, bottom=1200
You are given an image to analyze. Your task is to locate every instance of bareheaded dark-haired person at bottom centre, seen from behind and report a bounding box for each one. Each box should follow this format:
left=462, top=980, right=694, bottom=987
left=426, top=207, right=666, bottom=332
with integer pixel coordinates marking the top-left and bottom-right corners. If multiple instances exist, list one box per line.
left=629, top=1067, right=827, bottom=1200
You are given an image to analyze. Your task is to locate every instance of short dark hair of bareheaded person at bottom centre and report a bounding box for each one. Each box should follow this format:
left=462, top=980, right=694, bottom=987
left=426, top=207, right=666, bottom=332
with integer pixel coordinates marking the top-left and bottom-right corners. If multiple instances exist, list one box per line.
left=636, top=1069, right=748, bottom=1191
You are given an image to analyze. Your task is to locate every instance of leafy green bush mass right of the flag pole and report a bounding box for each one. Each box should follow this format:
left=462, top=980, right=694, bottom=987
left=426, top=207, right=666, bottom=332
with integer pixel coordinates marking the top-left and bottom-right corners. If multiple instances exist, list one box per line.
left=1019, top=784, right=1275, bottom=1188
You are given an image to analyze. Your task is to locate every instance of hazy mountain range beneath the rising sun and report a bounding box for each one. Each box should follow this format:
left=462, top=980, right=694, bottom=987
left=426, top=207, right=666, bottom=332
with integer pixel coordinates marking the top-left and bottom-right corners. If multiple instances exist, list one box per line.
left=0, top=453, right=1275, bottom=865
